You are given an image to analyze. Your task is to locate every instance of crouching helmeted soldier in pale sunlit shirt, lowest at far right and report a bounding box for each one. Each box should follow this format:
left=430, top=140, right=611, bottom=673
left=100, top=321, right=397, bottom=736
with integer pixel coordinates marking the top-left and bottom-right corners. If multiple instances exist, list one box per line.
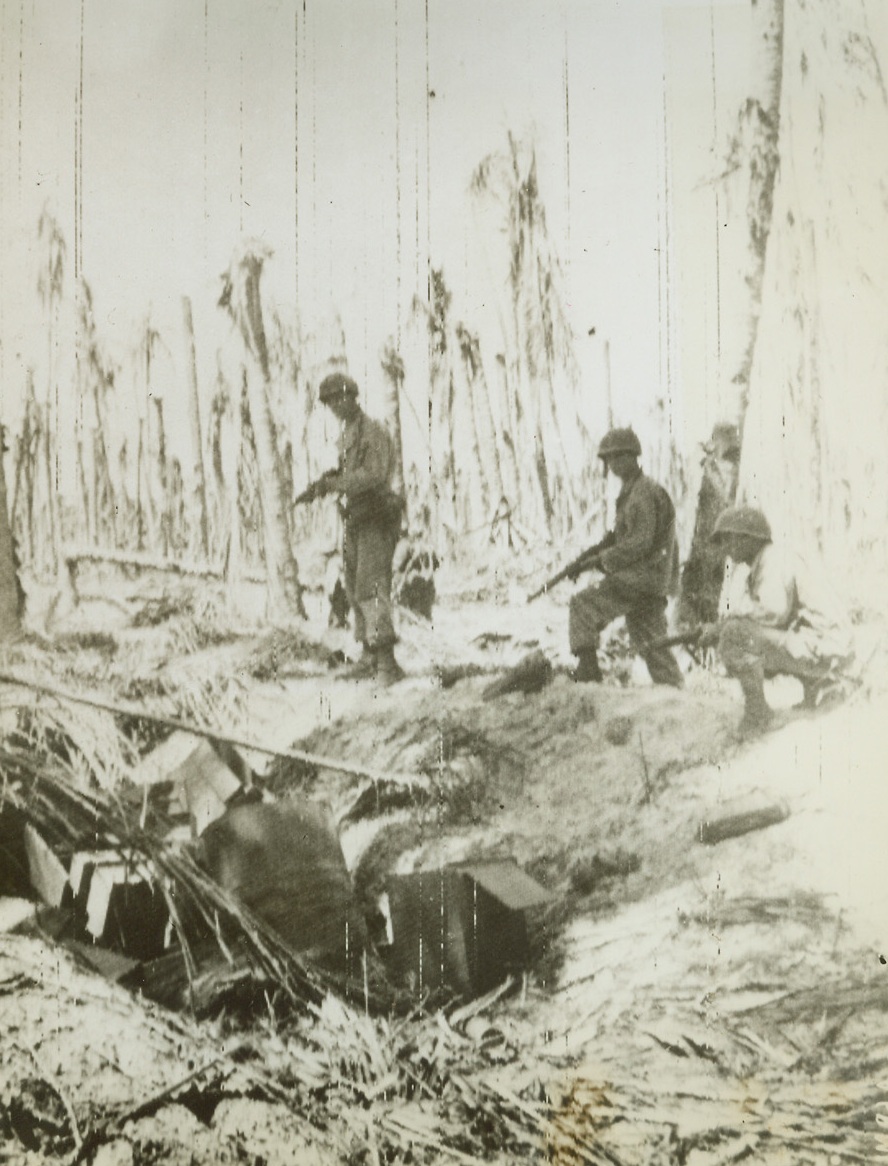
left=700, top=506, right=852, bottom=737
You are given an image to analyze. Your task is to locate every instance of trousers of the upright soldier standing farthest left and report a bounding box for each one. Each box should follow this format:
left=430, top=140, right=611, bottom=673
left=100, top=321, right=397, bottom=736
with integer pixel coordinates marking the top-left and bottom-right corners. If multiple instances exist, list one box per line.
left=343, top=515, right=401, bottom=648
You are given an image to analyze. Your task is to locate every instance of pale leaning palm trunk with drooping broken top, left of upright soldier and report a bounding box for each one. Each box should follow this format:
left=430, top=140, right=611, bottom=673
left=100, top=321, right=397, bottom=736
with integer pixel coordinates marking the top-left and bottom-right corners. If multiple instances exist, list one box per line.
left=223, top=248, right=305, bottom=618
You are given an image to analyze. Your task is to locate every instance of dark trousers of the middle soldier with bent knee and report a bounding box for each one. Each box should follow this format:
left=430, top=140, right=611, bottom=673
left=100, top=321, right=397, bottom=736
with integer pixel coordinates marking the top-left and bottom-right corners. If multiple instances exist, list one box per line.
left=568, top=578, right=684, bottom=688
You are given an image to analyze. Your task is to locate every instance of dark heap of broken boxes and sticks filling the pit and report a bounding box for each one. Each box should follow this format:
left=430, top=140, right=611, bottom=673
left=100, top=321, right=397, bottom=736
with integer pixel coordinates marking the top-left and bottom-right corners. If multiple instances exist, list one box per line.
left=0, top=680, right=550, bottom=1013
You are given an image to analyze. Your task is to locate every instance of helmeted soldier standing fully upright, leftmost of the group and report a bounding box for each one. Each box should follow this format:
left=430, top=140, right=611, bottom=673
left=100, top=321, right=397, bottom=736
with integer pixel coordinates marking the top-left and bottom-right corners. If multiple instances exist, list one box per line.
left=309, top=372, right=404, bottom=687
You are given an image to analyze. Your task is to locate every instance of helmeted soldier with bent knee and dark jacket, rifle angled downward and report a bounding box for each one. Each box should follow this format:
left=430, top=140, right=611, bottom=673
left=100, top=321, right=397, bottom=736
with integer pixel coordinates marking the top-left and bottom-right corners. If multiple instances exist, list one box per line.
left=569, top=429, right=684, bottom=688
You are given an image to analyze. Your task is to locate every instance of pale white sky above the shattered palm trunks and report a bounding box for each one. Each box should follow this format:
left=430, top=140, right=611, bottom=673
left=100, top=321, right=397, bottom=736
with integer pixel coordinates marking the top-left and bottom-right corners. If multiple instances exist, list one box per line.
left=0, top=0, right=747, bottom=473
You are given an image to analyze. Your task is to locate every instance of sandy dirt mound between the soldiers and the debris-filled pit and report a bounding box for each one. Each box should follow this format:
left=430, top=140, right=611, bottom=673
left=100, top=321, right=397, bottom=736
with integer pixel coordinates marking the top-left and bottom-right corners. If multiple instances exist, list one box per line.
left=298, top=676, right=738, bottom=893
